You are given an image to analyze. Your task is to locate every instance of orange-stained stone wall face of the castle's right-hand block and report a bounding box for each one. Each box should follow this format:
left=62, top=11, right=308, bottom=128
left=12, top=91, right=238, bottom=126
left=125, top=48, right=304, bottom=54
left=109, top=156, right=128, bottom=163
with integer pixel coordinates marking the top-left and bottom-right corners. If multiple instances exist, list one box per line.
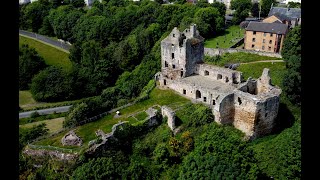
left=233, top=91, right=258, bottom=137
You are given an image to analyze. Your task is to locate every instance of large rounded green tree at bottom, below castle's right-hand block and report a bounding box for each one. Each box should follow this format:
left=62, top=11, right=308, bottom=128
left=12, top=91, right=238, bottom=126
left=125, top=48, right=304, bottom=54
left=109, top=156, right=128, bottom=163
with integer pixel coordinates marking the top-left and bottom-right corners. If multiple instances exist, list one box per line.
left=179, top=123, right=259, bottom=179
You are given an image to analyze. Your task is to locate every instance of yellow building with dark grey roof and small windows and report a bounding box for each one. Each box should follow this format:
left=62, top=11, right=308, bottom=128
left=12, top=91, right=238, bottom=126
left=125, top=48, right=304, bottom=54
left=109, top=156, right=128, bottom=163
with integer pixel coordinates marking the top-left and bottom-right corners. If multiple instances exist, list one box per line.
left=244, top=21, right=288, bottom=53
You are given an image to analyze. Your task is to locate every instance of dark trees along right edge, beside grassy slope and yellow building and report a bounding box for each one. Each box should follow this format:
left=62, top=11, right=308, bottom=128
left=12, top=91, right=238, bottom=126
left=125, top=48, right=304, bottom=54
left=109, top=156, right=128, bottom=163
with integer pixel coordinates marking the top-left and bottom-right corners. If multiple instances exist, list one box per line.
left=281, top=26, right=301, bottom=105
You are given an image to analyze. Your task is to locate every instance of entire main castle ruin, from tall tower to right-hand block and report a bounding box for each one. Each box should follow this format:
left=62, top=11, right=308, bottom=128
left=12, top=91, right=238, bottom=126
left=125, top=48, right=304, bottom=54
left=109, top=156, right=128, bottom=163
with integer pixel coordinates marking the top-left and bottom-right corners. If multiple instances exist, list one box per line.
left=158, top=25, right=281, bottom=139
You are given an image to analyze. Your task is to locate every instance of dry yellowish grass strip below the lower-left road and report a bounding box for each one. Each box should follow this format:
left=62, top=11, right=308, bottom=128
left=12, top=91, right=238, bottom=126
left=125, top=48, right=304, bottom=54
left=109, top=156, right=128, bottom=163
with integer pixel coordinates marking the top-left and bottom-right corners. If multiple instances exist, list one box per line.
left=19, top=117, right=65, bottom=133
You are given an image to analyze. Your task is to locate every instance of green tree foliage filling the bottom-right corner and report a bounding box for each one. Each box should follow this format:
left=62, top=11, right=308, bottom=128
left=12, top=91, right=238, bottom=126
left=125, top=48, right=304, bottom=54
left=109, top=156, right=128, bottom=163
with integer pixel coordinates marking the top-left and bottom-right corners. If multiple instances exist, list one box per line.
left=252, top=122, right=301, bottom=179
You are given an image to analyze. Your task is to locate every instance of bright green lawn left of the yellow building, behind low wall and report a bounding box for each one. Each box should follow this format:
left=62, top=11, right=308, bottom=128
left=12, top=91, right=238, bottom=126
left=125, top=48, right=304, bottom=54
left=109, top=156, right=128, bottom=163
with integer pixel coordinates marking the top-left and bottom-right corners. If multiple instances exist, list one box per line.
left=204, top=25, right=245, bottom=48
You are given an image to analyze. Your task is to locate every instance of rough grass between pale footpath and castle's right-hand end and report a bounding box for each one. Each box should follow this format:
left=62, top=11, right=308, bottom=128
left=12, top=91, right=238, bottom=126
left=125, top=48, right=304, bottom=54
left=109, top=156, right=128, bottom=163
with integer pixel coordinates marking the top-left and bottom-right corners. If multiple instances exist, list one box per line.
left=237, top=62, right=286, bottom=87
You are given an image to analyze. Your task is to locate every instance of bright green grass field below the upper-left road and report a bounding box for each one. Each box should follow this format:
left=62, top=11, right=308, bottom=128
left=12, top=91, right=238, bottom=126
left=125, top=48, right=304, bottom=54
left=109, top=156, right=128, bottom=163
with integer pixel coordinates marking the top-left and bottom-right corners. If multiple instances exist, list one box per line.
left=19, top=36, right=72, bottom=70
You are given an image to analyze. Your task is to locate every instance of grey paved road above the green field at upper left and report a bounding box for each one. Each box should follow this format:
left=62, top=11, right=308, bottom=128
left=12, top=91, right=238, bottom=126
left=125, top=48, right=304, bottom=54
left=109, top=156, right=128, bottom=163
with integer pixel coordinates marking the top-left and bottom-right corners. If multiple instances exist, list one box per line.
left=19, top=30, right=71, bottom=52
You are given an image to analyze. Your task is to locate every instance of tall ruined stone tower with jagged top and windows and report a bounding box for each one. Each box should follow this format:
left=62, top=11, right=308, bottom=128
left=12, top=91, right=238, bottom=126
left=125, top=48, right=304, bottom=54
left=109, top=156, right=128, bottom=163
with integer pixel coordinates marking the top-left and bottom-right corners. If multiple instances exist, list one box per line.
left=161, top=25, right=204, bottom=86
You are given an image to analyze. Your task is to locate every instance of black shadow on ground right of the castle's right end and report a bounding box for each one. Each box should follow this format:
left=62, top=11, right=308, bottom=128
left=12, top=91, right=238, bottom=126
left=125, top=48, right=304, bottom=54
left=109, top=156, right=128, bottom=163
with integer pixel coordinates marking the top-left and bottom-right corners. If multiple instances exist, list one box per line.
left=272, top=103, right=294, bottom=134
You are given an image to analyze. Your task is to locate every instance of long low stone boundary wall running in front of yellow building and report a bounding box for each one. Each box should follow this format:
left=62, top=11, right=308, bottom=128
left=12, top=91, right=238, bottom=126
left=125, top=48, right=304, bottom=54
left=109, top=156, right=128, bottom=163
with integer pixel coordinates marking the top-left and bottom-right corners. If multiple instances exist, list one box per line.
left=204, top=48, right=282, bottom=58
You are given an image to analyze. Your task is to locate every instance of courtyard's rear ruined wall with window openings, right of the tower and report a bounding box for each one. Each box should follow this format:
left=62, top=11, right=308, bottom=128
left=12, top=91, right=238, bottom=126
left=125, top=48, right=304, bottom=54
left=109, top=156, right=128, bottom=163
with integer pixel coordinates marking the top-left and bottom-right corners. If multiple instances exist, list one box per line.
left=197, top=64, right=242, bottom=85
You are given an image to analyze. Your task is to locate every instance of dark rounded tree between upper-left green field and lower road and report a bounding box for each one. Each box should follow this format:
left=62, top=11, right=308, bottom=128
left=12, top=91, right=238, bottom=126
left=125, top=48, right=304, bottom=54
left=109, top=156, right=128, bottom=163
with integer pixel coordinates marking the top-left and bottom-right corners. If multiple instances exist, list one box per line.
left=30, top=66, right=70, bottom=102
